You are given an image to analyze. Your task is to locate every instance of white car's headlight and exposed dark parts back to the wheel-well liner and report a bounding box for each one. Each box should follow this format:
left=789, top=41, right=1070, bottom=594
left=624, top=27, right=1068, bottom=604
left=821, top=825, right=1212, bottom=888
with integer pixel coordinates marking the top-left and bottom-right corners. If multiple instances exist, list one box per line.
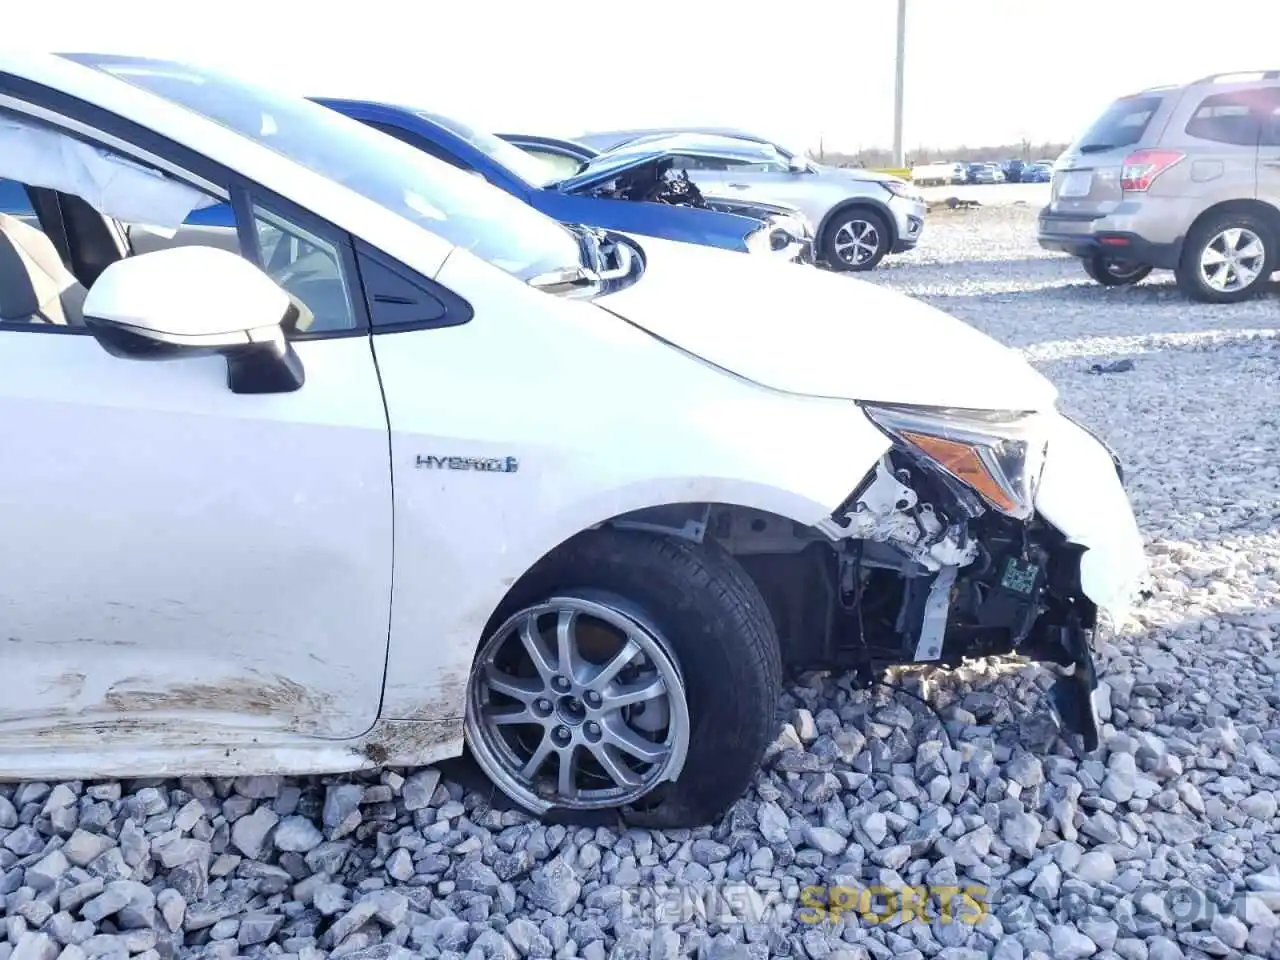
left=708, top=407, right=1140, bottom=750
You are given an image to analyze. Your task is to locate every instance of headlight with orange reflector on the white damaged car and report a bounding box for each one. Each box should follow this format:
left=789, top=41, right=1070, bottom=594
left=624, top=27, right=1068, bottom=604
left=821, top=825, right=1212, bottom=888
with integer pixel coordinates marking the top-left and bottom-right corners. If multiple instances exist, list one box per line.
left=861, top=403, right=1048, bottom=520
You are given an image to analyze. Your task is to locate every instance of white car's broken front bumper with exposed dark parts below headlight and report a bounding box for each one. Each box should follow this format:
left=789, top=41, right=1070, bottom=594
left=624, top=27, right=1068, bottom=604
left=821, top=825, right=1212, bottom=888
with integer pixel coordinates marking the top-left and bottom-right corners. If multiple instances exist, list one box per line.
left=814, top=415, right=1147, bottom=750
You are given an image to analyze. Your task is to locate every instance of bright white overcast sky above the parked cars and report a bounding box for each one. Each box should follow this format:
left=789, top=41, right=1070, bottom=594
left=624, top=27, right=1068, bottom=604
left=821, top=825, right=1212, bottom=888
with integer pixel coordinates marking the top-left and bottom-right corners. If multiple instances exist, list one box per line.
left=5, top=0, right=1280, bottom=151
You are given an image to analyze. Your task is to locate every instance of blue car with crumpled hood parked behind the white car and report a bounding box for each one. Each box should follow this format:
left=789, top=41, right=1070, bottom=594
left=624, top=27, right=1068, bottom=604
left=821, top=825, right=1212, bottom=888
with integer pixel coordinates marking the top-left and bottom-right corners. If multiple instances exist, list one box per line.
left=312, top=97, right=813, bottom=261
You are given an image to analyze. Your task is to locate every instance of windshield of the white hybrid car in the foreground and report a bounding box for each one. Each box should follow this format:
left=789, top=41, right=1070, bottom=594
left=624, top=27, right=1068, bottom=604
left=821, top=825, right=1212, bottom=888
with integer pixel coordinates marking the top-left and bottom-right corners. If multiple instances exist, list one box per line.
left=68, top=54, right=581, bottom=280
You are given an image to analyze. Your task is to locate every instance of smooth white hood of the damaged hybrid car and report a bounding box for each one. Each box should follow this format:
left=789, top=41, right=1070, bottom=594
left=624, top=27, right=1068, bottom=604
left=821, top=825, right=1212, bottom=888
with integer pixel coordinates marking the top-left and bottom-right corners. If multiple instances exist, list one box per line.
left=595, top=237, right=1057, bottom=410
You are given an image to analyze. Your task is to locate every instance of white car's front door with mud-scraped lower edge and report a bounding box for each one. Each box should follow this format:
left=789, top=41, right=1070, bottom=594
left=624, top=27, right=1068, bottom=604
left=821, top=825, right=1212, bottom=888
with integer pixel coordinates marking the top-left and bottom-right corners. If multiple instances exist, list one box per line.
left=0, top=116, right=392, bottom=757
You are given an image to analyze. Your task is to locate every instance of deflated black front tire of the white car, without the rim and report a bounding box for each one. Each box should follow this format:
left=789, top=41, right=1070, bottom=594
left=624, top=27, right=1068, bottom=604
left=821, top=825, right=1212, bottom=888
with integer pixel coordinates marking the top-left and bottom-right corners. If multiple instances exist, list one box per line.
left=486, top=529, right=782, bottom=828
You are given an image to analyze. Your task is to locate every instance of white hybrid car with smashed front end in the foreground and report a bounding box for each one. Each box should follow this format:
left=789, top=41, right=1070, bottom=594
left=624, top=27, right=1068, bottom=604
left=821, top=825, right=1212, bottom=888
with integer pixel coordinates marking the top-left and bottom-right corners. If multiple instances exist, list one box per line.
left=0, top=54, right=1146, bottom=824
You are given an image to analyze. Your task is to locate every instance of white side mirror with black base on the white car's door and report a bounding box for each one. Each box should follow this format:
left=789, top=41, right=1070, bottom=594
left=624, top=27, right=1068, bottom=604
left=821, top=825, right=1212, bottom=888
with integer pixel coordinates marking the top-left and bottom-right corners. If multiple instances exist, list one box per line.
left=83, top=246, right=305, bottom=393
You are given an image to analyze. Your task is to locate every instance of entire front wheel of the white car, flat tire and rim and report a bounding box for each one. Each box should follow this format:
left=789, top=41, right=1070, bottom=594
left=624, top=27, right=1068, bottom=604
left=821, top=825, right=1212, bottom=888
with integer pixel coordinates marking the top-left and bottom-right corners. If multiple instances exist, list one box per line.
left=465, top=529, right=782, bottom=827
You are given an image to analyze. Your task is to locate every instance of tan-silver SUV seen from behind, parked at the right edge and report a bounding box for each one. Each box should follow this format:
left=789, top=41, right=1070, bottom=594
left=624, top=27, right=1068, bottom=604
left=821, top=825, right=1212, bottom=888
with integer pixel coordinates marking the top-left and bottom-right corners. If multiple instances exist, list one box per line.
left=1039, top=70, right=1280, bottom=303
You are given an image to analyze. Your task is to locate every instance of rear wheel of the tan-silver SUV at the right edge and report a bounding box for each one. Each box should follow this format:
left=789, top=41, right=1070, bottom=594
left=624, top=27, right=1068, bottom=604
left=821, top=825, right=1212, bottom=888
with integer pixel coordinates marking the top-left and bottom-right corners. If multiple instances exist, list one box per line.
left=1178, top=212, right=1276, bottom=303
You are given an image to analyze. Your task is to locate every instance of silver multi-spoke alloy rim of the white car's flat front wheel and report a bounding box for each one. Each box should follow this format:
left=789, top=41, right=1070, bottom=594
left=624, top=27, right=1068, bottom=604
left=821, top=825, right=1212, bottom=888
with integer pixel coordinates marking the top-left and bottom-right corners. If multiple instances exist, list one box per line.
left=466, top=596, right=690, bottom=813
